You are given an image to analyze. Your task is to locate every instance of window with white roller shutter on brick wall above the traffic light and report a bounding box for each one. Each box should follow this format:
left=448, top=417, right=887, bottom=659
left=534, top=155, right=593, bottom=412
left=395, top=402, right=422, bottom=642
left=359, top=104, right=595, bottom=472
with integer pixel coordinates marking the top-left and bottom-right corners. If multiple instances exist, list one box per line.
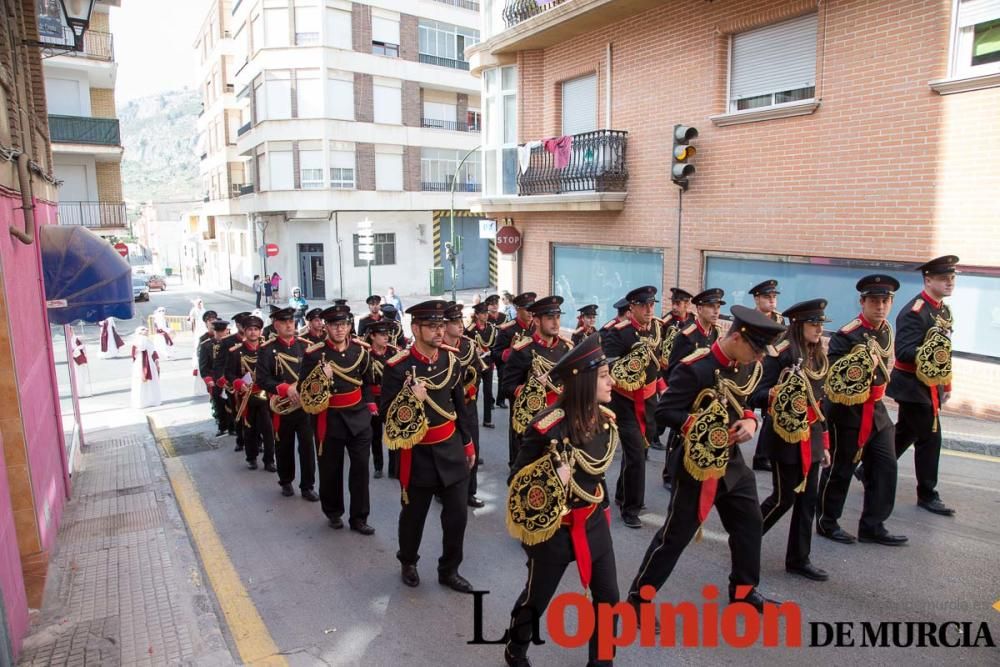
left=729, top=14, right=816, bottom=113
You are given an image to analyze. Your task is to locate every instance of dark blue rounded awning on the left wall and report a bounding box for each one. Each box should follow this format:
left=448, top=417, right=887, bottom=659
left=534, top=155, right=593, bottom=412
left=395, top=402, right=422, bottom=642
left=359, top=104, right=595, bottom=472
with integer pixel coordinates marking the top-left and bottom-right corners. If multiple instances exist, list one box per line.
left=41, top=225, right=134, bottom=324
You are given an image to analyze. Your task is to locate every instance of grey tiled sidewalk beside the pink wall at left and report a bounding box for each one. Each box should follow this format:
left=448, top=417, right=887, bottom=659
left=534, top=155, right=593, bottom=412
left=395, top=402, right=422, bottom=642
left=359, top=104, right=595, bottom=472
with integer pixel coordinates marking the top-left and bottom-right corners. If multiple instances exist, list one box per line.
left=19, top=424, right=234, bottom=666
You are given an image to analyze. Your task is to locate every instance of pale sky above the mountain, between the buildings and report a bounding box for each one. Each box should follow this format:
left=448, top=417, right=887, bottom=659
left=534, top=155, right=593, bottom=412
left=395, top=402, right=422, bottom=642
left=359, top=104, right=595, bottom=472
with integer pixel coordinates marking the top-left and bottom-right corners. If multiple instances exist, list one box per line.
left=111, top=0, right=211, bottom=105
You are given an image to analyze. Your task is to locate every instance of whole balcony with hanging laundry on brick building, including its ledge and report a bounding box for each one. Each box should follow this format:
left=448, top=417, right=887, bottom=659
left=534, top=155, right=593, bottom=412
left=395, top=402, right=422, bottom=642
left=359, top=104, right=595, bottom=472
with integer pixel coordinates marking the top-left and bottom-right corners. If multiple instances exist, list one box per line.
left=480, top=130, right=628, bottom=211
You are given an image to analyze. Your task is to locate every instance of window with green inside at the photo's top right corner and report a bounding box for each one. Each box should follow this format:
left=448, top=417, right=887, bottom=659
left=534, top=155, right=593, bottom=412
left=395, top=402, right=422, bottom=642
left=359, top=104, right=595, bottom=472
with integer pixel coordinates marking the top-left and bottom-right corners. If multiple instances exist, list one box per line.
left=951, top=0, right=1000, bottom=78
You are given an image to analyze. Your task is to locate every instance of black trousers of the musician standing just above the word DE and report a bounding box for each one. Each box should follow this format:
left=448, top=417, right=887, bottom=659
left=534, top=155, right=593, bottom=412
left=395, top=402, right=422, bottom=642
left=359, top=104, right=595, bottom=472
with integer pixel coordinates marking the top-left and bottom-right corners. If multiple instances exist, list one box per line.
left=760, top=464, right=820, bottom=567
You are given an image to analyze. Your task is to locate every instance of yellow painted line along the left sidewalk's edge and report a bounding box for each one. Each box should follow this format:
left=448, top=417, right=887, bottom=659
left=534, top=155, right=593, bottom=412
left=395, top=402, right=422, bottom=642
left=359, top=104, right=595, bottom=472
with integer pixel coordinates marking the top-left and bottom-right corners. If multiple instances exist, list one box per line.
left=150, top=418, right=288, bottom=667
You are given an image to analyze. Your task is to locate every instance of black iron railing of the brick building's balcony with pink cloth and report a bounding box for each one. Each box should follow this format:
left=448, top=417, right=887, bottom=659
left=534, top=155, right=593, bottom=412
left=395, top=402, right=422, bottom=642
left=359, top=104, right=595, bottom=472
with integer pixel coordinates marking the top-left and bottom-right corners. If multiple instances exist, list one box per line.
left=517, top=130, right=628, bottom=195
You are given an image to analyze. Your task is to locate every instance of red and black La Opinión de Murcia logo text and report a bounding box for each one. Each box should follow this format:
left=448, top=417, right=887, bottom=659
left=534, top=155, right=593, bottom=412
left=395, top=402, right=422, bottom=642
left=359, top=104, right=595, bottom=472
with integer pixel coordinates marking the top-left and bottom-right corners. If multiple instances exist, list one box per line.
left=467, top=584, right=996, bottom=660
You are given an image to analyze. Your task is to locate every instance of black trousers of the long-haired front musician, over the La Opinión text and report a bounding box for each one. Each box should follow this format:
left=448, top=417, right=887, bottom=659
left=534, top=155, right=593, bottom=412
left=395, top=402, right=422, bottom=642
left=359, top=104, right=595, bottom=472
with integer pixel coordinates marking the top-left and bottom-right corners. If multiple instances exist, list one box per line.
left=507, top=544, right=620, bottom=665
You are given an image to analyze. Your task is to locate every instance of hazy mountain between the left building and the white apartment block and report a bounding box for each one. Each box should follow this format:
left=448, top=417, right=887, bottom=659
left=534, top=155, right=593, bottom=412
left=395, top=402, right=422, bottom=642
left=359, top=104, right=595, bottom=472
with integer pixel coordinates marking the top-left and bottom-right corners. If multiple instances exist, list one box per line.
left=118, top=88, right=202, bottom=202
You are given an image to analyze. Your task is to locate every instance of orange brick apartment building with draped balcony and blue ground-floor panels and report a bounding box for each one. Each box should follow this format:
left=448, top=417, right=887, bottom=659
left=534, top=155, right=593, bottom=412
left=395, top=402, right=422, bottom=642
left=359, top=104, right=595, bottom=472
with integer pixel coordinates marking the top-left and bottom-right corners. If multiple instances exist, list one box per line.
left=466, top=0, right=1000, bottom=418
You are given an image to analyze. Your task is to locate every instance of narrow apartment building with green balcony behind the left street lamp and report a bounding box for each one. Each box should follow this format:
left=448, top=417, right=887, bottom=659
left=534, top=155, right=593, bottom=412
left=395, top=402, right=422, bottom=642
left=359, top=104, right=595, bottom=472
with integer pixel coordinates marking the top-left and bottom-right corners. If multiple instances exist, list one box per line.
left=42, top=0, right=128, bottom=236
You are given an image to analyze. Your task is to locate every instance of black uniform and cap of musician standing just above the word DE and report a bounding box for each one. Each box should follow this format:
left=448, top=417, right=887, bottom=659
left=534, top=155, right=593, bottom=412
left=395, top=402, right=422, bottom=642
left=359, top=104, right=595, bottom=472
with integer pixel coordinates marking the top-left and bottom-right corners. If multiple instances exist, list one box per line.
left=750, top=299, right=830, bottom=581
